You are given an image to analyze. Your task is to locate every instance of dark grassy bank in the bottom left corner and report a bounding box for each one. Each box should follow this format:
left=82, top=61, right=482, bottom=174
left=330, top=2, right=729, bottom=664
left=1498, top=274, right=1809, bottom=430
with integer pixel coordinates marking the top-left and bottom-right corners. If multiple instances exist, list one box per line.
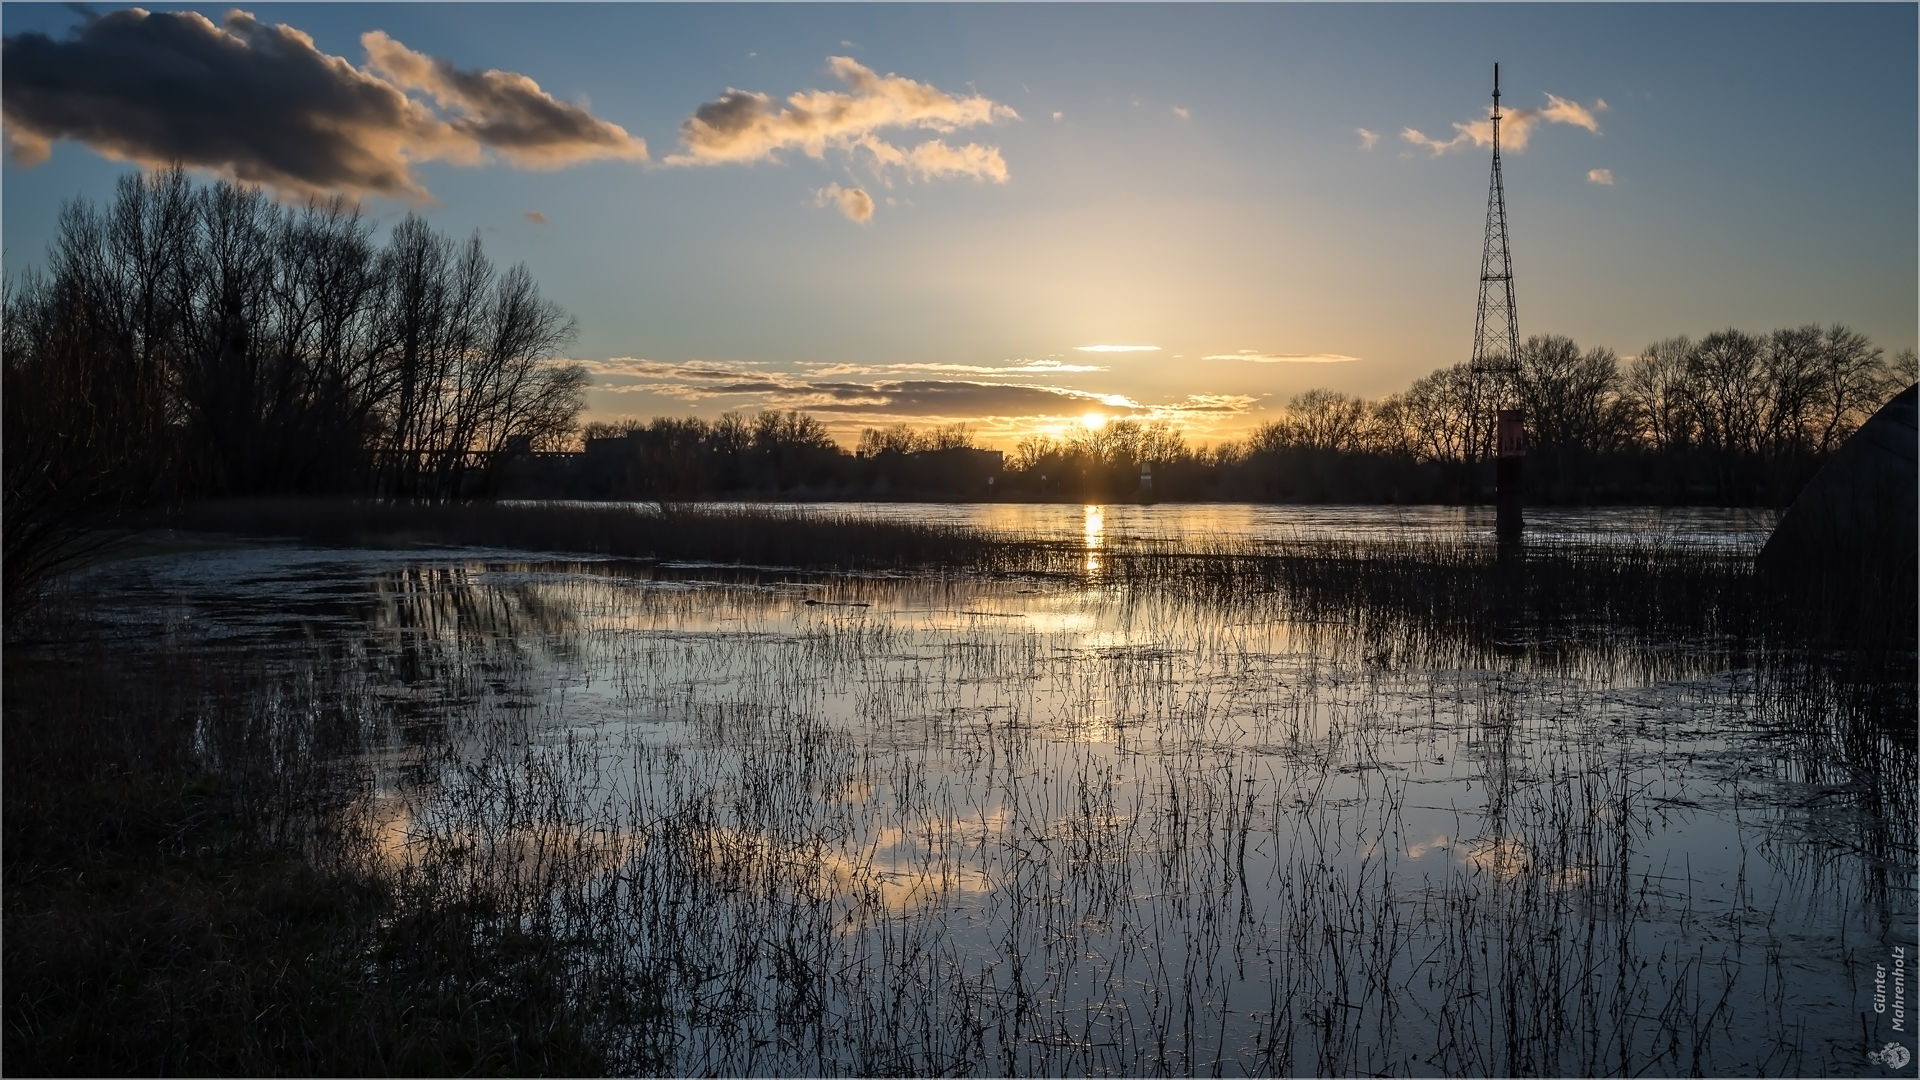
left=4, top=611, right=607, bottom=1076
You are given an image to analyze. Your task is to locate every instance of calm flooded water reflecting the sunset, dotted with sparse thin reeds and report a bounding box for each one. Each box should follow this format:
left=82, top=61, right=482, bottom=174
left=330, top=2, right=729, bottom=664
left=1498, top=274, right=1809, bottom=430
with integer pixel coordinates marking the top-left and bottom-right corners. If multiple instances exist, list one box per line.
left=41, top=507, right=1916, bottom=1076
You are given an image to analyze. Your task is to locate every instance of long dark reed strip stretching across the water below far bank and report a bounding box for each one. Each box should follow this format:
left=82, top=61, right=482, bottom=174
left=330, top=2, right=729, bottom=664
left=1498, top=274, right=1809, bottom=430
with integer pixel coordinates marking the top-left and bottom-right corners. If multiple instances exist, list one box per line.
left=156, top=500, right=1920, bottom=732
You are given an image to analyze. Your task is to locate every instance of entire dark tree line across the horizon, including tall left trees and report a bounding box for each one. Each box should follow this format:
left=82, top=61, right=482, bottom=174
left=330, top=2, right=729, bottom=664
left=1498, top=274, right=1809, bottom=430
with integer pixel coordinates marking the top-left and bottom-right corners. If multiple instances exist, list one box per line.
left=0, top=167, right=1914, bottom=596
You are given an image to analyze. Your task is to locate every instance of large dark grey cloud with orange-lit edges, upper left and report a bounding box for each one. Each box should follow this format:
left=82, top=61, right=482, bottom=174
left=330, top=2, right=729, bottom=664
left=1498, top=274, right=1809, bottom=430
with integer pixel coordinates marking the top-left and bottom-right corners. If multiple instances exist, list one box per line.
left=0, top=8, right=647, bottom=198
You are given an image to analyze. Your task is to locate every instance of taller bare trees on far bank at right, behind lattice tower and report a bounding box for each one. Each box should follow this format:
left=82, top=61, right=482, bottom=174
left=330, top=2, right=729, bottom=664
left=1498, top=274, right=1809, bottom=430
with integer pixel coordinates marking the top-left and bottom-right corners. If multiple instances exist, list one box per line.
left=1210, top=325, right=1916, bottom=505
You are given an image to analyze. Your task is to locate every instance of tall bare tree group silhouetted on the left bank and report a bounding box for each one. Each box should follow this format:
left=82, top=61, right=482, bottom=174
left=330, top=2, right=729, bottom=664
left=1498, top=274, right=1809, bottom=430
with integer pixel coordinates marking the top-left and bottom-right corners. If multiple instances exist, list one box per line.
left=4, top=167, right=588, bottom=580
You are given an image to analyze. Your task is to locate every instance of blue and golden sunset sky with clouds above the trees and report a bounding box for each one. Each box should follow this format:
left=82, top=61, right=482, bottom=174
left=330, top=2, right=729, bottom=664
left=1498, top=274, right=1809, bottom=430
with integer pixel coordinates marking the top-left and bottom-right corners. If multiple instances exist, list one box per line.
left=0, top=4, right=1920, bottom=448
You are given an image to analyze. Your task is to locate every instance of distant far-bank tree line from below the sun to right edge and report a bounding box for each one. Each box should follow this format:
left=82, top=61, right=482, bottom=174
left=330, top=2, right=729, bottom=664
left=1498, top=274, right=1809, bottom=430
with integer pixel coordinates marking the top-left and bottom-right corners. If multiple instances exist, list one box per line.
left=564, top=325, right=1914, bottom=505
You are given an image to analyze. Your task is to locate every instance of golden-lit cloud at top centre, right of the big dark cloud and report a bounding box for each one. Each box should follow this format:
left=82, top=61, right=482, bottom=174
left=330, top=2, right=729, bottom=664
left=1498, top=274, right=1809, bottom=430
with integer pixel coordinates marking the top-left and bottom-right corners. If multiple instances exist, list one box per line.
left=666, top=56, right=1020, bottom=201
